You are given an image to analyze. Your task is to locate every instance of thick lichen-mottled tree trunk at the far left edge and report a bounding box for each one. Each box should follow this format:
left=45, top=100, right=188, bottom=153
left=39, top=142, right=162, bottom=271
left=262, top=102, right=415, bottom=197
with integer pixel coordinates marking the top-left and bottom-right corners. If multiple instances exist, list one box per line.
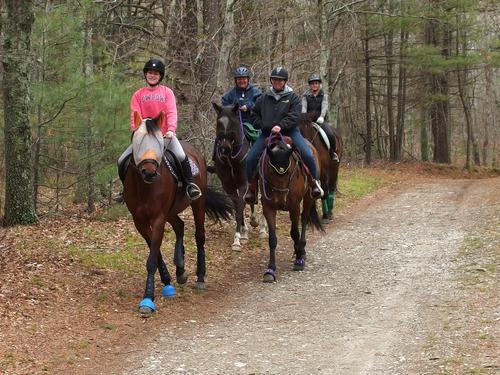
left=3, top=0, right=37, bottom=225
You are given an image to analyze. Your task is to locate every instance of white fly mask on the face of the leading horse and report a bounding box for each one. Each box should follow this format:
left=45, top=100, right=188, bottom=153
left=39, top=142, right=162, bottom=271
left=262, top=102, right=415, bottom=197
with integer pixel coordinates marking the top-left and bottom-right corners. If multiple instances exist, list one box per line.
left=132, top=120, right=164, bottom=165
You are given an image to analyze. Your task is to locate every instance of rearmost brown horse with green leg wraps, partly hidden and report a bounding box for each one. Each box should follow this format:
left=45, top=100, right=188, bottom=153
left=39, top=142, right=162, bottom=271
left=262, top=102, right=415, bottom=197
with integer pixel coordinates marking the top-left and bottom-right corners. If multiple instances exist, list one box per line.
left=298, top=113, right=344, bottom=224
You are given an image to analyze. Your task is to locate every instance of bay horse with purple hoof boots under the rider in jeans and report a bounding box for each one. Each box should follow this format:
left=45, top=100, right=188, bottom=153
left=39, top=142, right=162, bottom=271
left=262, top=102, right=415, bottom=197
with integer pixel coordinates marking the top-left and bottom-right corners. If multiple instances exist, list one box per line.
left=259, top=133, right=323, bottom=283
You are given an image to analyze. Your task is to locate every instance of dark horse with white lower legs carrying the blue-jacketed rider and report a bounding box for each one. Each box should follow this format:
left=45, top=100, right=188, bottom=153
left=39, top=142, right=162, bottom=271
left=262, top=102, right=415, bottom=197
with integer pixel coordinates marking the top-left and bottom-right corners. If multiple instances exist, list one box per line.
left=212, top=102, right=266, bottom=251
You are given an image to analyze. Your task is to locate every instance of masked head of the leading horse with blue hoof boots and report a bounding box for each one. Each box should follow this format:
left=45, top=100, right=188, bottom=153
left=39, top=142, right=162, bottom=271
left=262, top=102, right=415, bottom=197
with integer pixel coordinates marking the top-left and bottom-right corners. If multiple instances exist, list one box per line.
left=132, top=112, right=164, bottom=184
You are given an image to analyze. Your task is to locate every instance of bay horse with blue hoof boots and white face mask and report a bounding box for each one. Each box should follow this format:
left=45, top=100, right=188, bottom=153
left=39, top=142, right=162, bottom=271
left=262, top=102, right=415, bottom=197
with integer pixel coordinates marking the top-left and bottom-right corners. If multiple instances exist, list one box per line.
left=123, top=113, right=231, bottom=317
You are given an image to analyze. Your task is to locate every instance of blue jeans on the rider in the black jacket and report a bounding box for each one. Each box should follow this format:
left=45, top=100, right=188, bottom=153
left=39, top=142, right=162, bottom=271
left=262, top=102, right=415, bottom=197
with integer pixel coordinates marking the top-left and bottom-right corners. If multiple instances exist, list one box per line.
left=247, top=128, right=319, bottom=181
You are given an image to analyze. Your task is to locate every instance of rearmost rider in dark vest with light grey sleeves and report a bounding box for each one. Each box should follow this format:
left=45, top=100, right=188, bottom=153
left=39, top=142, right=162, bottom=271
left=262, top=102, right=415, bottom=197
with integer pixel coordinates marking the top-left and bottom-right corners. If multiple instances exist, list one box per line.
left=302, top=73, right=339, bottom=162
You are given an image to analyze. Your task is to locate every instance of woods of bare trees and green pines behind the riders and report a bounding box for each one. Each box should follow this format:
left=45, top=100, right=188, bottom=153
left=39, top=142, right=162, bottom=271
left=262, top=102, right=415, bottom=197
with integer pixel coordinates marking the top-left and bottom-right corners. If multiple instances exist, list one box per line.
left=0, top=0, right=500, bottom=225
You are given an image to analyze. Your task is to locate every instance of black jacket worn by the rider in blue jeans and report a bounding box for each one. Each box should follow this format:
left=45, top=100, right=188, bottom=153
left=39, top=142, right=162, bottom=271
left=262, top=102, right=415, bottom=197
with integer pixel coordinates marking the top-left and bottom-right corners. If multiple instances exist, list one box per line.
left=252, top=86, right=302, bottom=135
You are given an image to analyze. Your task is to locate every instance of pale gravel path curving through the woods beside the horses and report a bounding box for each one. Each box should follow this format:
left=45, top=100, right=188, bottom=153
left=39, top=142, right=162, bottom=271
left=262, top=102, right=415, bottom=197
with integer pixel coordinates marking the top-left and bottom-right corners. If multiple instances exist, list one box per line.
left=123, top=178, right=500, bottom=375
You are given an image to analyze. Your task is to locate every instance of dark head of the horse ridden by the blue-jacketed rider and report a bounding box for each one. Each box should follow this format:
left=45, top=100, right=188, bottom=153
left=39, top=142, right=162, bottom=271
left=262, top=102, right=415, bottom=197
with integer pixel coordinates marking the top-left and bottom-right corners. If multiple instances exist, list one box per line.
left=212, top=102, right=245, bottom=158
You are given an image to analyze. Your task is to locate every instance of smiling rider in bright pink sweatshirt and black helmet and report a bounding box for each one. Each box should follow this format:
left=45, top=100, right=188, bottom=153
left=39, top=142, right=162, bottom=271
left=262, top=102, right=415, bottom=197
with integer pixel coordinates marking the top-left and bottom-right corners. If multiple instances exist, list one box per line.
left=118, top=58, right=201, bottom=200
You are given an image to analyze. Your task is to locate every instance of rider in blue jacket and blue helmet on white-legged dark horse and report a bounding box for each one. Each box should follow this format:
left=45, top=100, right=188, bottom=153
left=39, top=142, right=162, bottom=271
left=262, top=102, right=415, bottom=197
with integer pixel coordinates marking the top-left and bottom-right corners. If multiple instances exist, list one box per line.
left=212, top=66, right=262, bottom=166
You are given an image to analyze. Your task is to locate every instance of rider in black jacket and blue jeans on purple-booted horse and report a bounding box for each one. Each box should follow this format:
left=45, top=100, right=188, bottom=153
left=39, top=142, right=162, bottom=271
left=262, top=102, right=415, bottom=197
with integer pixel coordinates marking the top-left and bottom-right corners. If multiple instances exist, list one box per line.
left=245, top=67, right=323, bottom=203
